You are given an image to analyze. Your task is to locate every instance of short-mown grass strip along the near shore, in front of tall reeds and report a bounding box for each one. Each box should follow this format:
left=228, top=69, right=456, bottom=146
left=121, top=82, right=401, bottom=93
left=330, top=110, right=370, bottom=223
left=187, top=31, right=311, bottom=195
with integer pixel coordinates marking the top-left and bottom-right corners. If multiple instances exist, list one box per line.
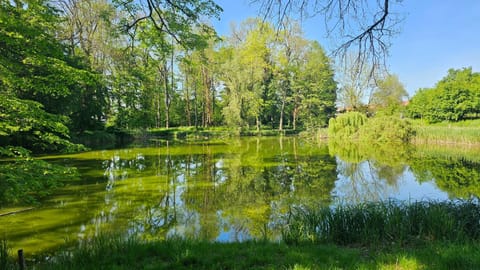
left=0, top=238, right=480, bottom=270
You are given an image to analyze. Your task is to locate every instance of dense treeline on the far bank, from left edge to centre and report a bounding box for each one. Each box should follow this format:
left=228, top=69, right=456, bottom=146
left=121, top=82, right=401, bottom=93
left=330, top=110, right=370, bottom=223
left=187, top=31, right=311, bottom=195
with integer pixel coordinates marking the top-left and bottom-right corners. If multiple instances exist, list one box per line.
left=0, top=0, right=337, bottom=156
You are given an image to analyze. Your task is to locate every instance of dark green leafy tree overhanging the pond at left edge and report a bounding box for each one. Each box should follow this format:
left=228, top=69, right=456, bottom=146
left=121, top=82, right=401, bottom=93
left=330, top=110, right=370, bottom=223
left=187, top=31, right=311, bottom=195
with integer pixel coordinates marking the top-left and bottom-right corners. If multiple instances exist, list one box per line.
left=0, top=1, right=103, bottom=151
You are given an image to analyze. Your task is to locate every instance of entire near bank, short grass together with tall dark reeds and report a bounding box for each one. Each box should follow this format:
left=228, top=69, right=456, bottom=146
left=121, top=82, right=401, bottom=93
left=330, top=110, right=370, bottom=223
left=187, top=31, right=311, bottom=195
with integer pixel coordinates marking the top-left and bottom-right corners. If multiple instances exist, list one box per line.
left=0, top=201, right=480, bottom=269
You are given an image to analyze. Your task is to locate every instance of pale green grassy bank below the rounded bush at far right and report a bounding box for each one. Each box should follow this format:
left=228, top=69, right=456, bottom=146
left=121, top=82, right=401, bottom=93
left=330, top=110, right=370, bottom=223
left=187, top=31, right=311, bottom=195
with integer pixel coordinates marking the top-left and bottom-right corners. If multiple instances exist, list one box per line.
left=412, top=119, right=480, bottom=144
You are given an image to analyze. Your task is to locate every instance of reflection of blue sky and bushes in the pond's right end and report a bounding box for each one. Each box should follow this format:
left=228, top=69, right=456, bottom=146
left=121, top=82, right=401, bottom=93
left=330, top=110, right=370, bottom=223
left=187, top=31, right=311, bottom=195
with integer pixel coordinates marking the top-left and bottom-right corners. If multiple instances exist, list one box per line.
left=329, top=141, right=480, bottom=202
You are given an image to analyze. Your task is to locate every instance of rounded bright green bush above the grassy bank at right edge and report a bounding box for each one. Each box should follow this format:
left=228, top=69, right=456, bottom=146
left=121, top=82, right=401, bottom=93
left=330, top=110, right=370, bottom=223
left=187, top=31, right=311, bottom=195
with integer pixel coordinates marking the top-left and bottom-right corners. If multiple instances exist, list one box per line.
left=408, top=68, right=480, bottom=123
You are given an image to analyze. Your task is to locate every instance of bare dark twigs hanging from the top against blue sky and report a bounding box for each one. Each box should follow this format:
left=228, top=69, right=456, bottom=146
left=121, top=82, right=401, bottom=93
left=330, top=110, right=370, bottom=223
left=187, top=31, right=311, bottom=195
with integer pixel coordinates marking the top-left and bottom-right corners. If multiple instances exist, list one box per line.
left=252, top=0, right=401, bottom=76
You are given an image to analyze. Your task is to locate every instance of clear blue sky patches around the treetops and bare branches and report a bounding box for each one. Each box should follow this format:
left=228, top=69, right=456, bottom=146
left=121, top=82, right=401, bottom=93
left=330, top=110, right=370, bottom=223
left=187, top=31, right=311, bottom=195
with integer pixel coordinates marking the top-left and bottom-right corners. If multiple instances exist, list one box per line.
left=214, top=0, right=480, bottom=95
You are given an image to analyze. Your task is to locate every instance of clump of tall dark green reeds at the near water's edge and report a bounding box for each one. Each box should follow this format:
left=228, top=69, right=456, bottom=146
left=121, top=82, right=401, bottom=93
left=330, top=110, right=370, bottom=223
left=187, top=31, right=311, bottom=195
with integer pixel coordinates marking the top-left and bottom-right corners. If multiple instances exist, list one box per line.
left=282, top=200, right=480, bottom=246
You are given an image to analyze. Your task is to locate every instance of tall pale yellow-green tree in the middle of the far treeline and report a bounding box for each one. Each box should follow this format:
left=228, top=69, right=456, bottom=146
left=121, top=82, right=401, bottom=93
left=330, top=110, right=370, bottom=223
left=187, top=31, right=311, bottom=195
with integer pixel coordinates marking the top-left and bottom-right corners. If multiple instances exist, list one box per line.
left=222, top=19, right=274, bottom=130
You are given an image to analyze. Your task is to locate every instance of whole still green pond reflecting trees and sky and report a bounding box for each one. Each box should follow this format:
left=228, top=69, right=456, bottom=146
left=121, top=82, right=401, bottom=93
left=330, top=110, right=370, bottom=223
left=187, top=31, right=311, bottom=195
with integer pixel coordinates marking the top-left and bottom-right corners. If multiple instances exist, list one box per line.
left=0, top=137, right=480, bottom=254
